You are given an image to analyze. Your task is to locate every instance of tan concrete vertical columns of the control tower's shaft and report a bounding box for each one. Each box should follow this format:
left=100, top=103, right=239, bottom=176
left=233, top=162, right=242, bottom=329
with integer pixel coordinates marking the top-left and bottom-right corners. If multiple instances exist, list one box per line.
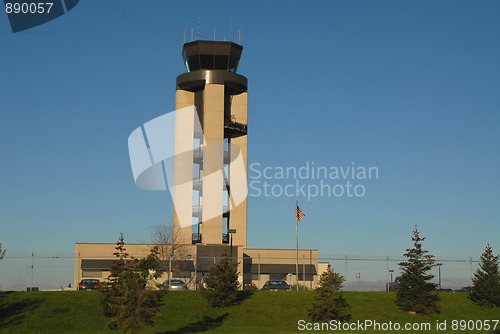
left=173, top=84, right=248, bottom=247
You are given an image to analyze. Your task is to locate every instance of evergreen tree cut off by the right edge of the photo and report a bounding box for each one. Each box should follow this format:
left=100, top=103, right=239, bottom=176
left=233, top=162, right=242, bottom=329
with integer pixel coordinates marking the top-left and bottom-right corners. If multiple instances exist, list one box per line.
left=469, top=244, right=500, bottom=307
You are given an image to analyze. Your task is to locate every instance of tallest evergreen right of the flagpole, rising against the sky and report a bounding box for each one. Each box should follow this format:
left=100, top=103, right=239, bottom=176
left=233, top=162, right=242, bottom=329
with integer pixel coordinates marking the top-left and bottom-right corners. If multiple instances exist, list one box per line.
left=396, top=226, right=439, bottom=314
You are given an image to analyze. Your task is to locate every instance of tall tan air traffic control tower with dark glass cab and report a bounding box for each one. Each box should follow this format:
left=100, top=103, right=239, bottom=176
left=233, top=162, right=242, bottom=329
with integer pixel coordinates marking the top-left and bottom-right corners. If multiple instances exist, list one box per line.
left=173, top=40, right=248, bottom=247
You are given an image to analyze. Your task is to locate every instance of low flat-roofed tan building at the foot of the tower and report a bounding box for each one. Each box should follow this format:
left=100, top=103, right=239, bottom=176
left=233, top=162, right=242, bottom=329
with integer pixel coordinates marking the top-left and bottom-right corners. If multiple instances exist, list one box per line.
left=74, top=242, right=326, bottom=290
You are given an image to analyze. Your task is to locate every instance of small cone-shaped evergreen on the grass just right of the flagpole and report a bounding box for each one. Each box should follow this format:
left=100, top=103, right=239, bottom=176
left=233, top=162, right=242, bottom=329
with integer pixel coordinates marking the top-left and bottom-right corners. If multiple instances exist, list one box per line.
left=308, top=265, right=351, bottom=322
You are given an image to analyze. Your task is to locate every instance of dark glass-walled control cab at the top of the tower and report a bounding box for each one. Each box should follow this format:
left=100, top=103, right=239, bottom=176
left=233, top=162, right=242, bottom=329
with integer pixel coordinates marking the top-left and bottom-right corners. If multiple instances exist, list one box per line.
left=182, top=41, right=243, bottom=73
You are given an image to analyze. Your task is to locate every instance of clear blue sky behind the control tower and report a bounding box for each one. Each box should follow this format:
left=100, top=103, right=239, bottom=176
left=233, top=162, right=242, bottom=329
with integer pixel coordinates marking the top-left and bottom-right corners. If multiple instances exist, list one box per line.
left=0, top=0, right=500, bottom=288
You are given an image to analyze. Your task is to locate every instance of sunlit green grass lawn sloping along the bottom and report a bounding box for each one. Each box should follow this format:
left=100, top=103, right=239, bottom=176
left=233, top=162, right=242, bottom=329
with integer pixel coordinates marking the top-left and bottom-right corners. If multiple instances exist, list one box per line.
left=0, top=291, right=500, bottom=334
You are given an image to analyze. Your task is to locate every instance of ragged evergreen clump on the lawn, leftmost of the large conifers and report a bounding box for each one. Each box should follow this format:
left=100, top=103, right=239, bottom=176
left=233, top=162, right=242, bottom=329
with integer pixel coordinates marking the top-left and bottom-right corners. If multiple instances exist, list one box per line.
left=102, top=234, right=161, bottom=333
